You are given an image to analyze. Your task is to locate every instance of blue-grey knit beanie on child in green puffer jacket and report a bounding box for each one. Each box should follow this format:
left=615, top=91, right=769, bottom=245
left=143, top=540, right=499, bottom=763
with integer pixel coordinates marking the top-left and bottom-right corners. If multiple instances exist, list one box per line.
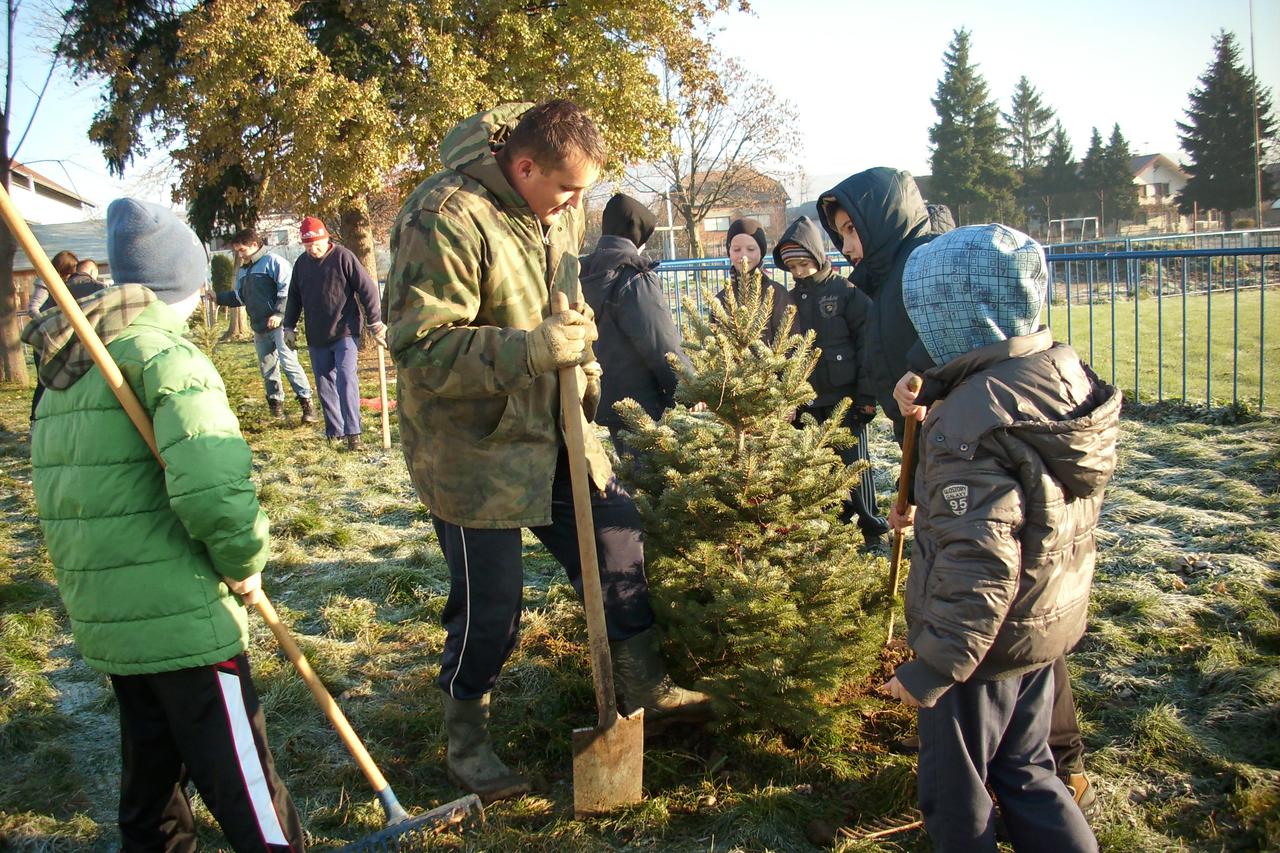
left=106, top=199, right=209, bottom=305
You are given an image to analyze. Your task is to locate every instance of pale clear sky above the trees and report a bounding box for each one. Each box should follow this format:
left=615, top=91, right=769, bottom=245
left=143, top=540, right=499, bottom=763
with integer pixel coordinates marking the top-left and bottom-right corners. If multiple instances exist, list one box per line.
left=10, top=0, right=1280, bottom=209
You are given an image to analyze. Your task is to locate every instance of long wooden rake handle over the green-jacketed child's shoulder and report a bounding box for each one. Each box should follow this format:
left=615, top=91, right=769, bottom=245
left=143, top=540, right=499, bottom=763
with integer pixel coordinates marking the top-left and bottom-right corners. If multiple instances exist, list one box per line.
left=0, top=180, right=399, bottom=792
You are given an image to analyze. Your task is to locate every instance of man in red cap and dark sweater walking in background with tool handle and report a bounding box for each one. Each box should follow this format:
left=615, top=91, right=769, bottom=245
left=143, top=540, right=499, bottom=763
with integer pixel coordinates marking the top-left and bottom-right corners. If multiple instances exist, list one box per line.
left=284, top=216, right=387, bottom=450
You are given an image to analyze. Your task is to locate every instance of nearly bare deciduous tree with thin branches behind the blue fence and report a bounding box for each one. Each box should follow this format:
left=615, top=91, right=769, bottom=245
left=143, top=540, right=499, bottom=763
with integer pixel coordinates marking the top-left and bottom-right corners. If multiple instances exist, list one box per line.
left=627, top=59, right=800, bottom=257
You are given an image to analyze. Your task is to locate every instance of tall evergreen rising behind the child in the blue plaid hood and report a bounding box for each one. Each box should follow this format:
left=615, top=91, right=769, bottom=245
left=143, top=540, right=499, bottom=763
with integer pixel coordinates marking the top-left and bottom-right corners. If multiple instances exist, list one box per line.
left=929, top=29, right=1018, bottom=223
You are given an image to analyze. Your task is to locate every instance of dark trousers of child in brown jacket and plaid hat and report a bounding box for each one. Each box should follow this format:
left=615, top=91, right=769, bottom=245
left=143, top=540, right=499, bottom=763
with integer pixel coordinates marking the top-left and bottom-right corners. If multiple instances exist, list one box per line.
left=919, top=666, right=1098, bottom=853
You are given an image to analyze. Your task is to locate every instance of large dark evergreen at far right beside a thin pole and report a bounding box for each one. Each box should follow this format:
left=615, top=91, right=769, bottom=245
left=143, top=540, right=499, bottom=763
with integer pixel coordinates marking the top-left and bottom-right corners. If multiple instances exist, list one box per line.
left=1178, top=31, right=1276, bottom=227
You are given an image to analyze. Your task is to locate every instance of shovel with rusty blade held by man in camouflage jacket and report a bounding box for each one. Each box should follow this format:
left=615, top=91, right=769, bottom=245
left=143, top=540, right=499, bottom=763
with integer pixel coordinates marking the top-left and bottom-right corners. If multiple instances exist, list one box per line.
left=552, top=292, right=644, bottom=817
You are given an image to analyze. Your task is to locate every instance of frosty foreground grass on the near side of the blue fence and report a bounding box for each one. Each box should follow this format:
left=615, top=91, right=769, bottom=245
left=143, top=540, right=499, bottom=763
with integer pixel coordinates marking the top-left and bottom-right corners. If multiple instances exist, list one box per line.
left=0, top=327, right=1280, bottom=853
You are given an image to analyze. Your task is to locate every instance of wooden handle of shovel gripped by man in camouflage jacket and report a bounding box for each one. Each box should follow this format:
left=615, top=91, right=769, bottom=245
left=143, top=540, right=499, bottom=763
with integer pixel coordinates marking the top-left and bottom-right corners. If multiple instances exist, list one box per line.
left=552, top=291, right=618, bottom=729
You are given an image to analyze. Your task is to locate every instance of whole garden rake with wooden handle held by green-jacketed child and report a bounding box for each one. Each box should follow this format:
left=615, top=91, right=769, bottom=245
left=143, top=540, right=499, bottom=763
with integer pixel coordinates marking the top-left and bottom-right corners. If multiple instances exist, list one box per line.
left=0, top=186, right=484, bottom=849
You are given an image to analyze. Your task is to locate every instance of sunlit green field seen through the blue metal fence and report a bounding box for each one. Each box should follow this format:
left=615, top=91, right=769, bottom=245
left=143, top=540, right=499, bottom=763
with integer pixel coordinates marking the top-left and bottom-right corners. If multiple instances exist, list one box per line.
left=1047, top=287, right=1280, bottom=411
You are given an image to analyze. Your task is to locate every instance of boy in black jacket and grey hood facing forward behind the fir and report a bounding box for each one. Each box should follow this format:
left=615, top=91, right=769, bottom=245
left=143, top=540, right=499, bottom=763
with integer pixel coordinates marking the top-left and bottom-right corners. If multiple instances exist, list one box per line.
left=773, top=216, right=888, bottom=547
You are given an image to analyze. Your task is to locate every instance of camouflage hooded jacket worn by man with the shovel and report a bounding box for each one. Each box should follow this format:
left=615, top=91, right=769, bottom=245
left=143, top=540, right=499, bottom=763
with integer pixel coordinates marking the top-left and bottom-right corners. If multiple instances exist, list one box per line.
left=383, top=104, right=612, bottom=528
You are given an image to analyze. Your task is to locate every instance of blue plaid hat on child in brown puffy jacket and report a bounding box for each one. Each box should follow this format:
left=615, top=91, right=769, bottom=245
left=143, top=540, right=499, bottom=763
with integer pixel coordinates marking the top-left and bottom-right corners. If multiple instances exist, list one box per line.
left=902, top=224, right=1046, bottom=365
